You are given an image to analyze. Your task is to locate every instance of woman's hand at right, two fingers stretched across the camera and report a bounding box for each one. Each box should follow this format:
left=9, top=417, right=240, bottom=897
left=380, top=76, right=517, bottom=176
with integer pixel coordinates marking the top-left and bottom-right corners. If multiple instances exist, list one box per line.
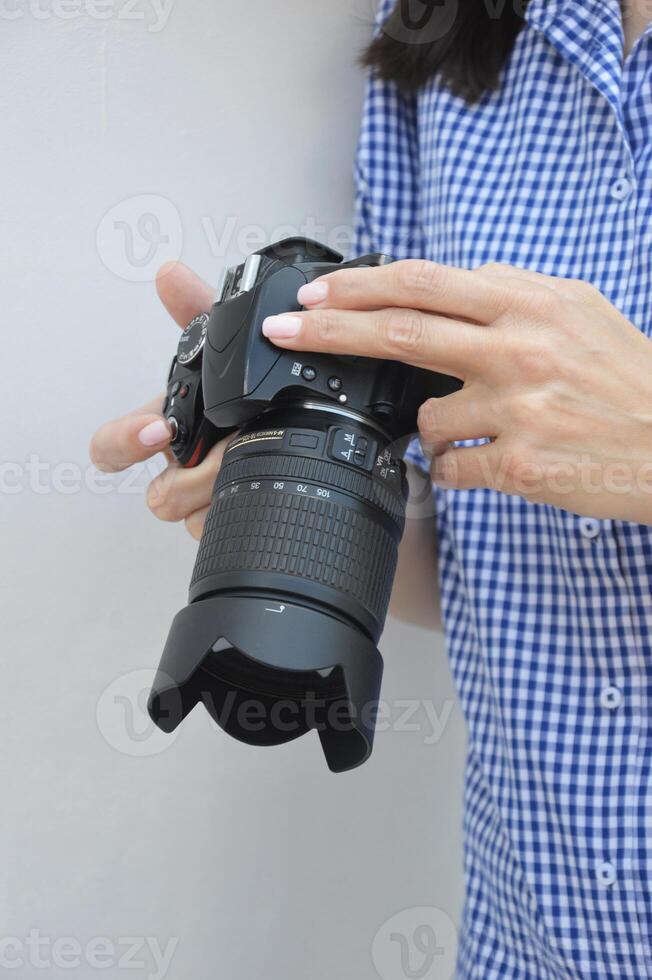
left=263, top=261, right=652, bottom=524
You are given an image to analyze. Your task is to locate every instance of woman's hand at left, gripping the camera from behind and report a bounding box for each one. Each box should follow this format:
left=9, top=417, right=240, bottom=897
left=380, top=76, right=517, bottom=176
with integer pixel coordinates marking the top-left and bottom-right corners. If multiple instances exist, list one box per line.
left=90, top=263, right=228, bottom=539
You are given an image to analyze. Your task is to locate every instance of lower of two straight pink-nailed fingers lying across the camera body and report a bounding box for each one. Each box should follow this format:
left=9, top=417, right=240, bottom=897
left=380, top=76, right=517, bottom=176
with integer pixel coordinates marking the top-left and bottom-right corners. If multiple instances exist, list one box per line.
left=263, top=309, right=488, bottom=379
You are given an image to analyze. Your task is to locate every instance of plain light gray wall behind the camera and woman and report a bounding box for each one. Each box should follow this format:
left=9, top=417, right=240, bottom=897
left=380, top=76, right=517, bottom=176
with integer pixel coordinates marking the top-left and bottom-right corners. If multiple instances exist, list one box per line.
left=0, top=0, right=463, bottom=980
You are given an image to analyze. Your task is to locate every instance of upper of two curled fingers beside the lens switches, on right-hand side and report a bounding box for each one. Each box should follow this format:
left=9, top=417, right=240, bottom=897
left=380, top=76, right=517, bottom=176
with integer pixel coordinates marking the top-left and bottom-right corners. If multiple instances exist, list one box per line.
left=418, top=385, right=499, bottom=455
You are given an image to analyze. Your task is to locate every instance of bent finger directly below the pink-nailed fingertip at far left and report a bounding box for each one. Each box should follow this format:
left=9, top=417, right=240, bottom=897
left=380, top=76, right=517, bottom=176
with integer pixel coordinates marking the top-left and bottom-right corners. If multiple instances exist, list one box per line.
left=147, top=440, right=225, bottom=522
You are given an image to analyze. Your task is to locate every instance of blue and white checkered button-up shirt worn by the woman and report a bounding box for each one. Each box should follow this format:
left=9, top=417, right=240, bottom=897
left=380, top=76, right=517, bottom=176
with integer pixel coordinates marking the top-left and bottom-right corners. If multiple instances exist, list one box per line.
left=356, top=0, right=652, bottom=980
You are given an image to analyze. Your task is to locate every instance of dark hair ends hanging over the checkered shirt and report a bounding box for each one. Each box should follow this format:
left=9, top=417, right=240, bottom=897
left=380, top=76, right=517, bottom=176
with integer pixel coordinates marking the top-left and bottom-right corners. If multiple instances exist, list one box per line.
left=362, top=0, right=528, bottom=102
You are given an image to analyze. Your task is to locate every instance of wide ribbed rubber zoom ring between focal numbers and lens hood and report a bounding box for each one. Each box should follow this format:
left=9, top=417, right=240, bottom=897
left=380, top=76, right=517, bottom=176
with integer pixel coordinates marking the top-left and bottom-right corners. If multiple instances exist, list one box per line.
left=190, top=470, right=398, bottom=624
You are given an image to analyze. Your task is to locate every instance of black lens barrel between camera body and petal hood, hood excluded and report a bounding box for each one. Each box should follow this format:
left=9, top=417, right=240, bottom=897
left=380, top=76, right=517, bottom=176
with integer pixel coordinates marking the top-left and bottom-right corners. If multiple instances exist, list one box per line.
left=190, top=411, right=405, bottom=640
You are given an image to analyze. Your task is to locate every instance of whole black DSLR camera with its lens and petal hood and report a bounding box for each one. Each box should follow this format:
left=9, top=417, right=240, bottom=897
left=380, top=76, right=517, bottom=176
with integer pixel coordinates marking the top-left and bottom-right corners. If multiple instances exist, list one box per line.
left=149, top=238, right=461, bottom=771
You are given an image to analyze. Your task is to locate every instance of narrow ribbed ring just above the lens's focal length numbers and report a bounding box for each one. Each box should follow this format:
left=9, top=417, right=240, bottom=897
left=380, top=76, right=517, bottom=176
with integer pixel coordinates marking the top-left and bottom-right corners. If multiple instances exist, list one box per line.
left=215, top=455, right=405, bottom=534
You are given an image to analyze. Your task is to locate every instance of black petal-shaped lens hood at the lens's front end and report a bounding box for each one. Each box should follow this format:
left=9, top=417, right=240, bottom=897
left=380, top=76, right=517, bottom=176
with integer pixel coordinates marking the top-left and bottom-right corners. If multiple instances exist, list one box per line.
left=148, top=594, right=383, bottom=772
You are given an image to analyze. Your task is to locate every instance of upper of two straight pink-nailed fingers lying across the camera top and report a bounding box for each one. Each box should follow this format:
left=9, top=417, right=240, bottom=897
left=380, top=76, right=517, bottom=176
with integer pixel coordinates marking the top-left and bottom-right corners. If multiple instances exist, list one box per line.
left=298, top=259, right=524, bottom=324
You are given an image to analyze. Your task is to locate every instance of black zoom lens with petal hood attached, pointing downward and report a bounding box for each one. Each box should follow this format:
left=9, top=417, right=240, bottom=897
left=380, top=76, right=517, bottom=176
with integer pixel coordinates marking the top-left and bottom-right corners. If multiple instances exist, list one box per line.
left=149, top=403, right=407, bottom=771
